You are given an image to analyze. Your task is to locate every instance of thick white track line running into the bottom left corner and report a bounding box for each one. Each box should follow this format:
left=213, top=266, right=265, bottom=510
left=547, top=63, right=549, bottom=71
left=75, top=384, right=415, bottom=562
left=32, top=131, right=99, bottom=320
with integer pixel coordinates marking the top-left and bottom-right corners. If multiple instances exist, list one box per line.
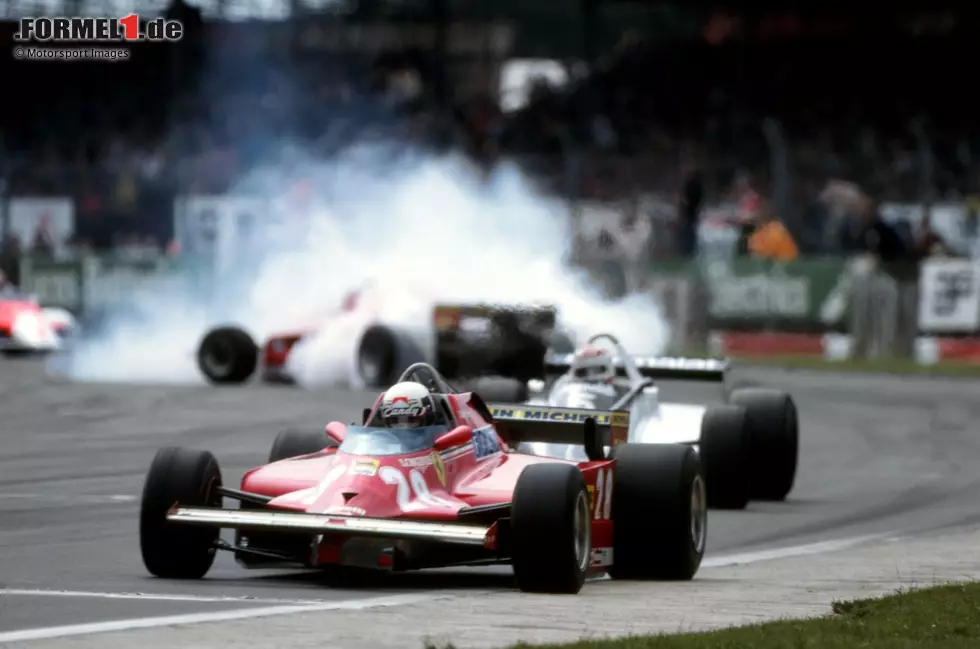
left=0, top=593, right=449, bottom=643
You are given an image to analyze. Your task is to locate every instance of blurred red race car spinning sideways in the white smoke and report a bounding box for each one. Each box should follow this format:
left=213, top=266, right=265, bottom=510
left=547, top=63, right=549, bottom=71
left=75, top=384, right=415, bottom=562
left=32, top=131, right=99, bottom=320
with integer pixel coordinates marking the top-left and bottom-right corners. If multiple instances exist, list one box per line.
left=197, top=285, right=572, bottom=390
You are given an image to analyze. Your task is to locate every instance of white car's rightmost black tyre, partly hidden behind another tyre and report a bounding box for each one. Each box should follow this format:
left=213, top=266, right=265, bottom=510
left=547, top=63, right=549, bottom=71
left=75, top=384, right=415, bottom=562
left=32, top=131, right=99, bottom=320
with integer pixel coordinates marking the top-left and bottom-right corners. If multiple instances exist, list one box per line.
left=730, top=388, right=800, bottom=500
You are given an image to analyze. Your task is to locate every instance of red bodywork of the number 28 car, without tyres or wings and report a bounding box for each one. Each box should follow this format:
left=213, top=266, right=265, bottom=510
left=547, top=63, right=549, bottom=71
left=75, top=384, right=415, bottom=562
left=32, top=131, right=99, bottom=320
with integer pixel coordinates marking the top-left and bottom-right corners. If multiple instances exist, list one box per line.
left=235, top=393, right=615, bottom=571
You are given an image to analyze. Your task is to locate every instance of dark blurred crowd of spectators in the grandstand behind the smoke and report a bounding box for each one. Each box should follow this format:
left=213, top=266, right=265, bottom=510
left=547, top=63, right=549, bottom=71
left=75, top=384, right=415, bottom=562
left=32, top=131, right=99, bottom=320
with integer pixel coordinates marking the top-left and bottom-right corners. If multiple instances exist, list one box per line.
left=0, top=6, right=980, bottom=278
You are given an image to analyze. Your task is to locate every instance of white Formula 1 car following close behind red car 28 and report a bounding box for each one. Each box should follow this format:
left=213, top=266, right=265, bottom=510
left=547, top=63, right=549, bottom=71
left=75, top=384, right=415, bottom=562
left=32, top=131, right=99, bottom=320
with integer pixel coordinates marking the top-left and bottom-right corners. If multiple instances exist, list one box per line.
left=523, top=334, right=799, bottom=509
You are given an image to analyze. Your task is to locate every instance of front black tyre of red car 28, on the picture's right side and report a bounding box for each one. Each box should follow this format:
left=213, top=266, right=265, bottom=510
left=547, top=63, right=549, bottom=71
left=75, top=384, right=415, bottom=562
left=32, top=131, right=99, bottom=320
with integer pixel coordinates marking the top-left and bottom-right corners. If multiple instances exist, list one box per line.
left=510, top=464, right=592, bottom=594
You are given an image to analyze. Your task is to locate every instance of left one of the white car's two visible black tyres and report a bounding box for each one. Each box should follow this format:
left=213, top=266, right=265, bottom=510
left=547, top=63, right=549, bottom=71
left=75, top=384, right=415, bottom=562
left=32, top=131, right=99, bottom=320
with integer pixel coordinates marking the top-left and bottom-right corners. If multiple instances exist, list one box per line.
left=699, top=406, right=752, bottom=509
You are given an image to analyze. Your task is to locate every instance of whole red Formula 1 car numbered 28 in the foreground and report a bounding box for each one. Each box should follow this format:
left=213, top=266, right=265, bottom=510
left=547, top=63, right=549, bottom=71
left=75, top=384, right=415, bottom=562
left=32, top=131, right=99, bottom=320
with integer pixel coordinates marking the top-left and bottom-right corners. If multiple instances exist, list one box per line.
left=140, top=363, right=707, bottom=593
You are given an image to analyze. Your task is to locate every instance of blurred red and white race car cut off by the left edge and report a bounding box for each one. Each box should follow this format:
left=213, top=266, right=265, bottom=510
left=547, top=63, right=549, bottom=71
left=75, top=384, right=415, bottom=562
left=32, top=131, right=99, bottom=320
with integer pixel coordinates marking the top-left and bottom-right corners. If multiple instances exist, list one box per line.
left=0, top=288, right=77, bottom=356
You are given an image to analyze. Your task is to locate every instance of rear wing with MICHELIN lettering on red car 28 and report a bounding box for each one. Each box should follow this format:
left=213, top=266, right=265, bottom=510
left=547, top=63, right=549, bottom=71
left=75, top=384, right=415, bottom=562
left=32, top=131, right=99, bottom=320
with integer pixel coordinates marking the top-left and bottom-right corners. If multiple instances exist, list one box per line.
left=488, top=404, right=630, bottom=446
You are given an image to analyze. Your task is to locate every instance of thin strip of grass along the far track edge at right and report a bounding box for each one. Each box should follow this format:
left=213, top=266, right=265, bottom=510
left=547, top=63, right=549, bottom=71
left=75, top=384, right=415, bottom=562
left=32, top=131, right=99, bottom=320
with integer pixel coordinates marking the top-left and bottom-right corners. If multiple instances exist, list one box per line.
left=735, top=355, right=980, bottom=378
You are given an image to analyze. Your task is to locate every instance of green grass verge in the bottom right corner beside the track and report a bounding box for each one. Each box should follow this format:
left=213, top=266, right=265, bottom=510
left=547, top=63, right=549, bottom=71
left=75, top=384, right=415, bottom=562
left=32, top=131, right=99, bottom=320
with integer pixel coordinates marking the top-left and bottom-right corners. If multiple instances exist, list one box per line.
left=458, top=583, right=980, bottom=649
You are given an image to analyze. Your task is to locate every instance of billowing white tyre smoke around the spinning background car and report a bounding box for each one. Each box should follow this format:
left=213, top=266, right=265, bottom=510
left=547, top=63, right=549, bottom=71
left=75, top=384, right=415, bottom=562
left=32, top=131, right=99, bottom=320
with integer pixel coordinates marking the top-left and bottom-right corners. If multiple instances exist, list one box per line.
left=58, top=145, right=668, bottom=387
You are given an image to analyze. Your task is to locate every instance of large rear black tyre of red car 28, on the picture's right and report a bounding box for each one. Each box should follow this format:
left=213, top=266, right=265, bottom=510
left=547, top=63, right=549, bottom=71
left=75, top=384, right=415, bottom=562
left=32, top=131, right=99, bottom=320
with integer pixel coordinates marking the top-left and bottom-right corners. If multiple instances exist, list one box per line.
left=609, top=444, right=708, bottom=580
